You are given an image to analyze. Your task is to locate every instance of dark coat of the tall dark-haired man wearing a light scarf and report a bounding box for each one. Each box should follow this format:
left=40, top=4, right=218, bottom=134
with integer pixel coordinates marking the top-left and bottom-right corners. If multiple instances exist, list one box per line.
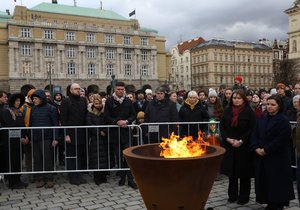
left=104, top=97, right=136, bottom=147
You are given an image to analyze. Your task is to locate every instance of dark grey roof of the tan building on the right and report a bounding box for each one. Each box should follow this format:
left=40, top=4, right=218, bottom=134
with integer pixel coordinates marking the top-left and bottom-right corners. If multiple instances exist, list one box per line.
left=193, top=39, right=272, bottom=50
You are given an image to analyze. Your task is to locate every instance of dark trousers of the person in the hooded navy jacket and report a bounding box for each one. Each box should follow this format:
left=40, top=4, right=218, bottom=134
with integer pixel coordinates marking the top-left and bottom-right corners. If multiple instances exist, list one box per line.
left=32, top=139, right=54, bottom=181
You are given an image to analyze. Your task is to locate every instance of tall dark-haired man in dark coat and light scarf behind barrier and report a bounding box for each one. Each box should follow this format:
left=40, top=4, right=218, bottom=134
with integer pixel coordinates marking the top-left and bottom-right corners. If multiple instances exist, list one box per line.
left=104, top=82, right=137, bottom=189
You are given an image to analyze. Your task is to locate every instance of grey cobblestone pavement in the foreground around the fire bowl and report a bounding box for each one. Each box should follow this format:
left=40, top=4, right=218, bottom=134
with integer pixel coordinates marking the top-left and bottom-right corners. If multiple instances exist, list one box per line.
left=0, top=172, right=300, bottom=210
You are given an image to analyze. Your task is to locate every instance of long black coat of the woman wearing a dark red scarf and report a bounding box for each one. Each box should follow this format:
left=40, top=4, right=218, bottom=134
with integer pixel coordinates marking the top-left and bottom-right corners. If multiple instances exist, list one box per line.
left=220, top=105, right=255, bottom=178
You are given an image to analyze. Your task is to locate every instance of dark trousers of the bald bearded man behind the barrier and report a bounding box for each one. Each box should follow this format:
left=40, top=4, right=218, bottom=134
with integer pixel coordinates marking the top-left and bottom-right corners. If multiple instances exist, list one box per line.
left=65, top=143, right=88, bottom=178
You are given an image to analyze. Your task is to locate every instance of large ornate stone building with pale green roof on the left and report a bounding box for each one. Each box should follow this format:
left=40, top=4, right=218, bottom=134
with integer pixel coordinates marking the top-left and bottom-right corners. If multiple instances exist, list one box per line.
left=0, top=3, right=168, bottom=91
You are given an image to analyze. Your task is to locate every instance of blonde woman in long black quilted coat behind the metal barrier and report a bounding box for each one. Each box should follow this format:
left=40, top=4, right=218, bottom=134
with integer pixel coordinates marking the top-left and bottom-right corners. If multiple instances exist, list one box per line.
left=86, top=94, right=108, bottom=185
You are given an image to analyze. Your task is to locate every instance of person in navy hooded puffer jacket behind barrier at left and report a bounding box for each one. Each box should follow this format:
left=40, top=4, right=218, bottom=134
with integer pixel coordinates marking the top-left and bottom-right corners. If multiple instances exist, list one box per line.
left=29, top=89, right=58, bottom=188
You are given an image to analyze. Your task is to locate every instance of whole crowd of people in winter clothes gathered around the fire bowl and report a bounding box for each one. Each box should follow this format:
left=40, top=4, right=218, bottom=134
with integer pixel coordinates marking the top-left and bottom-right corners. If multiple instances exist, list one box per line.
left=0, top=76, right=300, bottom=210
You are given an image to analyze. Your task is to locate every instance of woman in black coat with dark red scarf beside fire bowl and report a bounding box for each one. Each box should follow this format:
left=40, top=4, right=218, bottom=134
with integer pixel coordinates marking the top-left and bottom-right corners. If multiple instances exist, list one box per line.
left=220, top=89, right=255, bottom=205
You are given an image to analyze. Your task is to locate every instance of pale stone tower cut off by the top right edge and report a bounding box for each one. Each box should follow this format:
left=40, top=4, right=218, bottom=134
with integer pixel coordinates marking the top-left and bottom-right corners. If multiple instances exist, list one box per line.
left=285, top=0, right=300, bottom=59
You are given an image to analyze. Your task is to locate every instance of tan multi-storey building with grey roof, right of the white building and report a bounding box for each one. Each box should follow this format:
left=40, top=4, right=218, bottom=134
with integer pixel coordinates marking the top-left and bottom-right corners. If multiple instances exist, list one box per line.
left=191, top=39, right=274, bottom=89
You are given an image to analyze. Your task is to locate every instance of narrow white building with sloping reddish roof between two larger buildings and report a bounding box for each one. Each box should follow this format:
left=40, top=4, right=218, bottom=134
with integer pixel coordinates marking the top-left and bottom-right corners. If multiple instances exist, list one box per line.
left=169, top=37, right=205, bottom=91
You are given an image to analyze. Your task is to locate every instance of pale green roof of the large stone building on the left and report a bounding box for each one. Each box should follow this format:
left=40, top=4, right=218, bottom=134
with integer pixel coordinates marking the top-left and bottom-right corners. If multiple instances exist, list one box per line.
left=30, top=2, right=129, bottom=20
